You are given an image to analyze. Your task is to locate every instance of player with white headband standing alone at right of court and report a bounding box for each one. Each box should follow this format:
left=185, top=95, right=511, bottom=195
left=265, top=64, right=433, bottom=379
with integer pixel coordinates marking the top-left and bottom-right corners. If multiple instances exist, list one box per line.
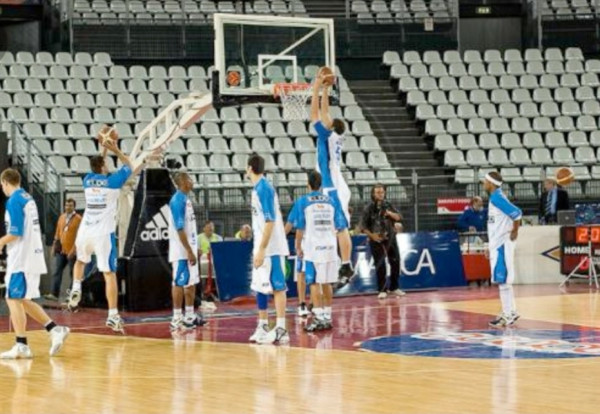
left=483, top=171, right=523, bottom=327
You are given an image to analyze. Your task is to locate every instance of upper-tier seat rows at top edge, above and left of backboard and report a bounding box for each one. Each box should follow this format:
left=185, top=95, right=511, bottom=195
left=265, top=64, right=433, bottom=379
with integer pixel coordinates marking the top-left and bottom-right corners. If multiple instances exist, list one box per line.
left=73, top=0, right=306, bottom=24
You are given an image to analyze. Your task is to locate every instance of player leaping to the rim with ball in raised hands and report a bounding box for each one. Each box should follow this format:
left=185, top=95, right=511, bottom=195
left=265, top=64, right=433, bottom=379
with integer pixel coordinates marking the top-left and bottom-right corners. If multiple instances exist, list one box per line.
left=310, top=68, right=354, bottom=287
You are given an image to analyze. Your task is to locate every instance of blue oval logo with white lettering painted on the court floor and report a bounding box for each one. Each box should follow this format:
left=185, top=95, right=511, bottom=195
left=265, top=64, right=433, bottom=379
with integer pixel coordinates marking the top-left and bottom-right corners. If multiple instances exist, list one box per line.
left=361, top=329, right=600, bottom=359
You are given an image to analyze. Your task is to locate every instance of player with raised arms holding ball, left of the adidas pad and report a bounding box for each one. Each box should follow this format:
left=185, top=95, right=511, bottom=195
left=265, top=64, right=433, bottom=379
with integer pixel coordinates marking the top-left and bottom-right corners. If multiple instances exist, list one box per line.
left=67, top=127, right=132, bottom=332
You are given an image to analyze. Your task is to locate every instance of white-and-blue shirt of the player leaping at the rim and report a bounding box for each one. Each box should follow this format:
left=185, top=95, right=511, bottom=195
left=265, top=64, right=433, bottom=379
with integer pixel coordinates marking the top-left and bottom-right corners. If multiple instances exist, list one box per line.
left=314, top=121, right=350, bottom=193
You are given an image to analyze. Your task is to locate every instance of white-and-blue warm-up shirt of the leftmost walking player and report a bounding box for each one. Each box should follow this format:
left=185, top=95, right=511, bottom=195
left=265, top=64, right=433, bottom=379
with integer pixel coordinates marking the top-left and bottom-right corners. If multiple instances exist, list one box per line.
left=4, top=188, right=48, bottom=275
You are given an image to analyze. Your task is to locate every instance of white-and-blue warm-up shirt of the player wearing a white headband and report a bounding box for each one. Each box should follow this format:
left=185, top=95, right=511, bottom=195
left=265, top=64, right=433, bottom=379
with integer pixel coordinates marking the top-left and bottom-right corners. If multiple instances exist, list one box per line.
left=487, top=188, right=523, bottom=250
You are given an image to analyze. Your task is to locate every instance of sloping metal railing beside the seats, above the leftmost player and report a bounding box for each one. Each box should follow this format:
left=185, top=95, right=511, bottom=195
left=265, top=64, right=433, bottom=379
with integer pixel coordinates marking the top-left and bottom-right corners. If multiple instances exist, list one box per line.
left=7, top=119, right=64, bottom=243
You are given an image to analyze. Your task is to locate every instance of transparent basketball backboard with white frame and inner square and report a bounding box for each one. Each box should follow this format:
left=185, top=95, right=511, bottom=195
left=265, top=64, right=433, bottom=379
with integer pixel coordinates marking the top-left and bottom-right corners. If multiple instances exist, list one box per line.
left=212, top=14, right=335, bottom=107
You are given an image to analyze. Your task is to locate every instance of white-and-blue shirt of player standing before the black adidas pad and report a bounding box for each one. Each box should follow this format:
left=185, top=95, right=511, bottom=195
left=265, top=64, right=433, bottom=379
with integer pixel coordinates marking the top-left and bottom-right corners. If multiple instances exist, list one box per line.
left=169, top=190, right=198, bottom=262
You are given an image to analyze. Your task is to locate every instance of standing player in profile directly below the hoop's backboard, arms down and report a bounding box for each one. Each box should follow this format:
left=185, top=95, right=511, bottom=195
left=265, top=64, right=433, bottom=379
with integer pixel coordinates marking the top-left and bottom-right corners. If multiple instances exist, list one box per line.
left=246, top=154, right=290, bottom=344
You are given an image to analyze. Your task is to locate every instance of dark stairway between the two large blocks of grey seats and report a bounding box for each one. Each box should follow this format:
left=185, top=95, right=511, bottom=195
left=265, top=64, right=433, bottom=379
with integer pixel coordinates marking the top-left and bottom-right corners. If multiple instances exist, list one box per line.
left=348, top=80, right=456, bottom=230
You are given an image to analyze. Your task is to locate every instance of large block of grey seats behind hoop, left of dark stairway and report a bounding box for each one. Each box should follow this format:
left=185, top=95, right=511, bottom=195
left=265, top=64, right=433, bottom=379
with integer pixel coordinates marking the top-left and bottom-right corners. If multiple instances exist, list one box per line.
left=0, top=52, right=399, bottom=201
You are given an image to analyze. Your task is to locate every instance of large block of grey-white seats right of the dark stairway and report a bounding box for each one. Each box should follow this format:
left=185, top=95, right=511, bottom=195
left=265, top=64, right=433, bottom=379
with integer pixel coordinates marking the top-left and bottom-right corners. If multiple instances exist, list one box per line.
left=383, top=48, right=600, bottom=197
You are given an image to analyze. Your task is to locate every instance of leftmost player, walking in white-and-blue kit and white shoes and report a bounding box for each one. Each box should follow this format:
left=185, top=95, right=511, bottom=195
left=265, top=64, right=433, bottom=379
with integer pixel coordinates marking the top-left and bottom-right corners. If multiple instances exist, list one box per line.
left=0, top=168, right=69, bottom=359
